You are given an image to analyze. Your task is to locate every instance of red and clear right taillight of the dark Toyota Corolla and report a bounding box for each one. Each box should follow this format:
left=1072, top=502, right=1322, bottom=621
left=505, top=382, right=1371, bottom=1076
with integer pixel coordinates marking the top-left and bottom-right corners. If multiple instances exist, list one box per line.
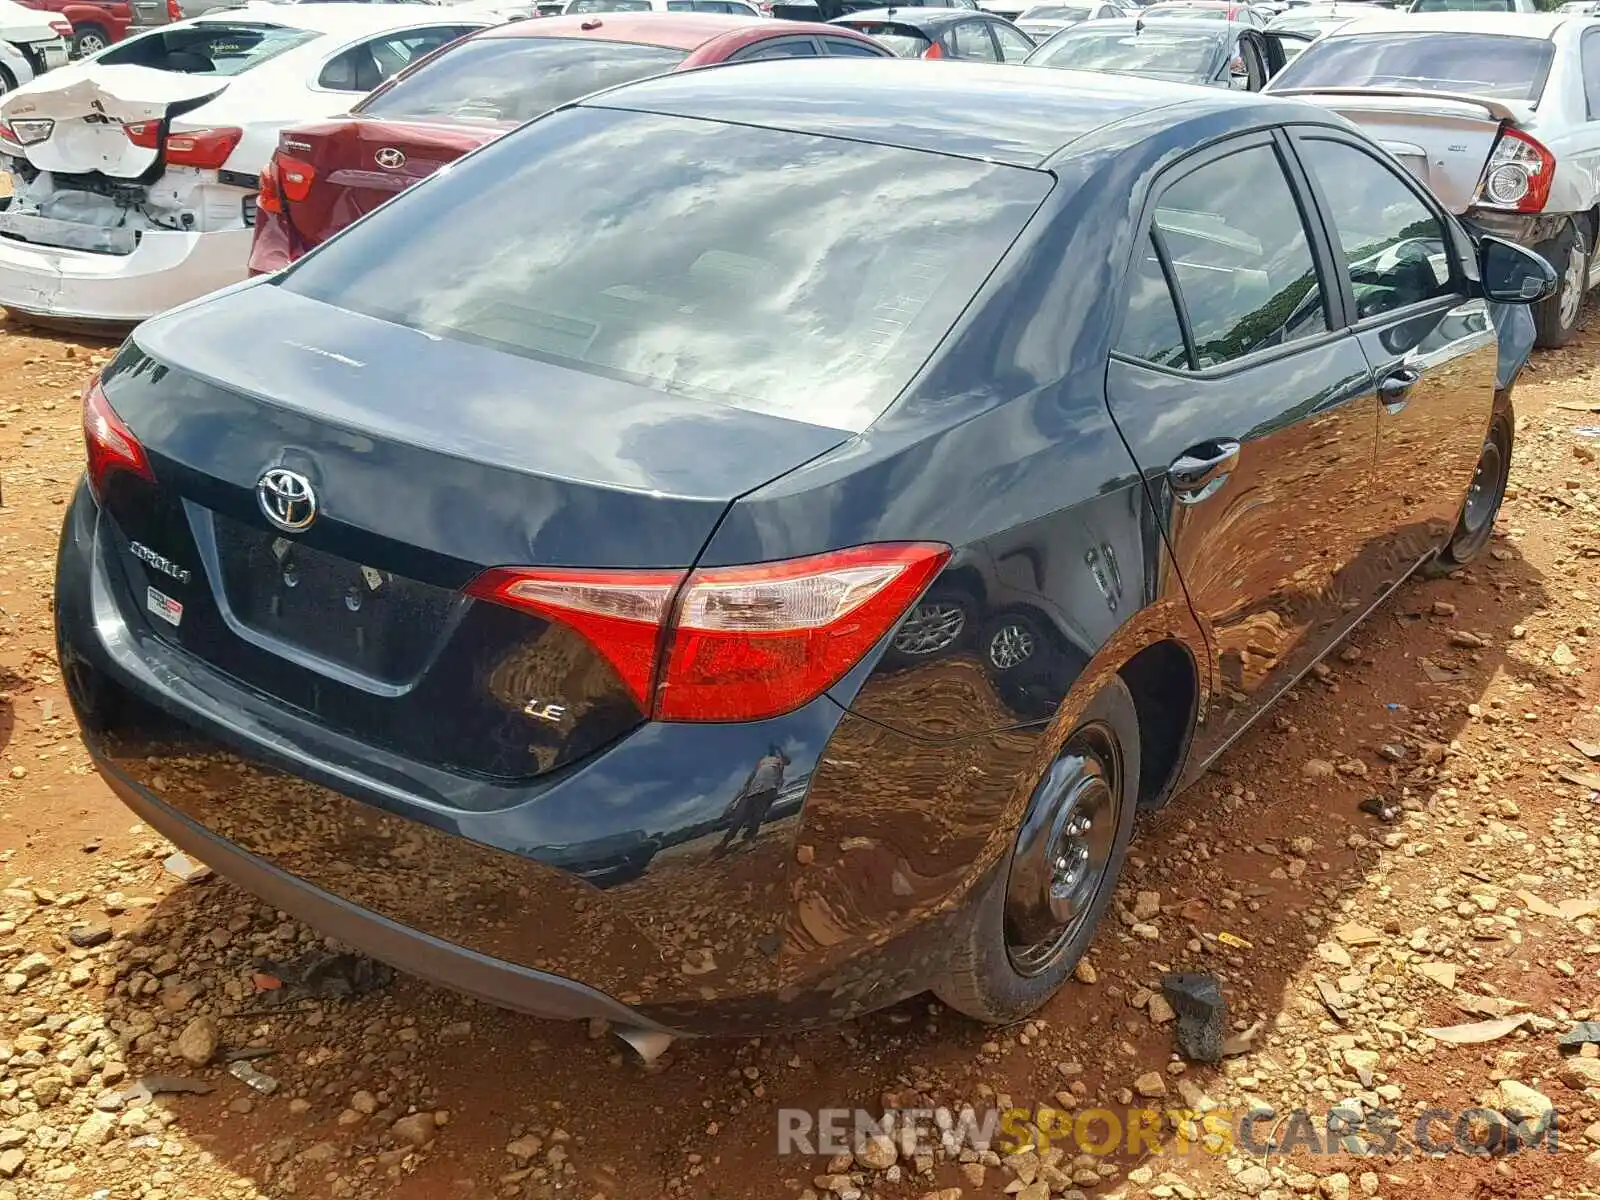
left=467, top=542, right=950, bottom=722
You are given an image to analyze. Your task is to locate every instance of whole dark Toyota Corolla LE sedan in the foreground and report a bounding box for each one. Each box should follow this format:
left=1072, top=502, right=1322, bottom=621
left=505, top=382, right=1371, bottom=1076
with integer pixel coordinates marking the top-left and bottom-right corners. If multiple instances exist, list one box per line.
left=56, top=61, right=1550, bottom=1048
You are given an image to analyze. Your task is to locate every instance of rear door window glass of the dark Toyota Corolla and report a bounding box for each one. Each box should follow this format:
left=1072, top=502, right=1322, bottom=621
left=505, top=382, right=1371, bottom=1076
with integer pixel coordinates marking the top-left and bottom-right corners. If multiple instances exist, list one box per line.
left=1155, top=146, right=1328, bottom=368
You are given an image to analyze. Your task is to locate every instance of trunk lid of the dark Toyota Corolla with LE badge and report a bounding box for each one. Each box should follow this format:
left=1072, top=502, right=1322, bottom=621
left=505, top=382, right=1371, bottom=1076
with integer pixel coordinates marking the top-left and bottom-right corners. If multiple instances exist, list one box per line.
left=90, top=285, right=848, bottom=779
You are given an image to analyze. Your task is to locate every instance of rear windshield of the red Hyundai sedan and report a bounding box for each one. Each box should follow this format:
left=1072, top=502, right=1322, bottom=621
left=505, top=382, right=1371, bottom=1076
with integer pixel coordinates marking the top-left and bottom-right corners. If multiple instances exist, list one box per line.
left=355, top=37, right=688, bottom=125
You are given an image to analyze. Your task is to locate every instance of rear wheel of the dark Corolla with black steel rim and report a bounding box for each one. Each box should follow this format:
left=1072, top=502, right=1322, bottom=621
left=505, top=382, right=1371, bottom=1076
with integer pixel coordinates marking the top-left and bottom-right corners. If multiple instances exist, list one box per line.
left=933, top=678, right=1139, bottom=1024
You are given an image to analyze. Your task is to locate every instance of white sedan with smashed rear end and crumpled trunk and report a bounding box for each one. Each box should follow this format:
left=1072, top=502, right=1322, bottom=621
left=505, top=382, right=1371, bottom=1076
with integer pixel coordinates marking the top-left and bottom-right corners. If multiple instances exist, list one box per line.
left=0, top=3, right=494, bottom=323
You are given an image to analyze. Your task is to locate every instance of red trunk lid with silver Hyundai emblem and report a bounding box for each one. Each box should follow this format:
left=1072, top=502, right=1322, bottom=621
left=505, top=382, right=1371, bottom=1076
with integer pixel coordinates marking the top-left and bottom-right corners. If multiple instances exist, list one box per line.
left=275, top=118, right=499, bottom=248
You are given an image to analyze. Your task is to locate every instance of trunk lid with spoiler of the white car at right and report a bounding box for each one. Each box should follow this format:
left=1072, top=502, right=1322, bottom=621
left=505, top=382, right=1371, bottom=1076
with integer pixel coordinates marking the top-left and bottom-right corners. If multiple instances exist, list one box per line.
left=1277, top=88, right=1533, bottom=213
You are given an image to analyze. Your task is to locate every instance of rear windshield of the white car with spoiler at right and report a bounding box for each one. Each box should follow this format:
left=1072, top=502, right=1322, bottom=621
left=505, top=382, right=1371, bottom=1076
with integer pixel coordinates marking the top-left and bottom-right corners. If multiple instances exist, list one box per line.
left=1272, top=30, right=1554, bottom=101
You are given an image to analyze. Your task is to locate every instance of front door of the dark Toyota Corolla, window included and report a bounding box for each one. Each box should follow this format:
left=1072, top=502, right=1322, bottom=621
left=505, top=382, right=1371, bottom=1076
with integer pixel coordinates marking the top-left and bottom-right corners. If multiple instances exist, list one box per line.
left=1294, top=126, right=1499, bottom=578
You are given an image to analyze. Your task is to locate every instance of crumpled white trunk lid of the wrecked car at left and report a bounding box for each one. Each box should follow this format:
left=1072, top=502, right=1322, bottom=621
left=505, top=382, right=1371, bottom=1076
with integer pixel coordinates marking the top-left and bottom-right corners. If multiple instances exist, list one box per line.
left=0, top=66, right=227, bottom=181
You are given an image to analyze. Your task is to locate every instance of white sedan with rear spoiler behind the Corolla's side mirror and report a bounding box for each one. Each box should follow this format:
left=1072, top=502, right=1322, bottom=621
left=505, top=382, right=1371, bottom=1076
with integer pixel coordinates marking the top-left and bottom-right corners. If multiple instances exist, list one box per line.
left=1266, top=13, right=1600, bottom=347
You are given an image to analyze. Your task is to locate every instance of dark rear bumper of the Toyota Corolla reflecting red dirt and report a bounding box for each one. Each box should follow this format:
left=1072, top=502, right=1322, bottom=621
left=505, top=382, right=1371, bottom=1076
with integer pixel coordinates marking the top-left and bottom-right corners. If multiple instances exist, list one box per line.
left=56, top=486, right=1037, bottom=1034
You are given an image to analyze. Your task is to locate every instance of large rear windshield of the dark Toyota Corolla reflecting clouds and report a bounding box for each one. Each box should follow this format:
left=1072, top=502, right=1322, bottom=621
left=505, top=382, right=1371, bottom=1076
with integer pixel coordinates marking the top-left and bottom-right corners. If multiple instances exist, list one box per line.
left=277, top=107, right=1050, bottom=432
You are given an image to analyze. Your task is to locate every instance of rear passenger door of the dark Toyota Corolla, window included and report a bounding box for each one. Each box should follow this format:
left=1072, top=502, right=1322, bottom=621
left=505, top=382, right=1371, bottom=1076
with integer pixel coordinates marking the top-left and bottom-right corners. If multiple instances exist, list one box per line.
left=1107, top=134, right=1382, bottom=763
